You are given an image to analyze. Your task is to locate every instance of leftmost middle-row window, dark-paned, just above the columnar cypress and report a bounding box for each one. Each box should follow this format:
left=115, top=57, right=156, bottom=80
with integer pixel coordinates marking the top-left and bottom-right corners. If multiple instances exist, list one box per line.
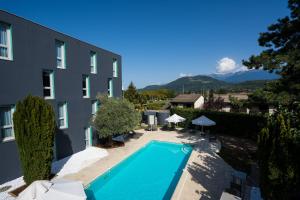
left=43, top=70, right=54, bottom=99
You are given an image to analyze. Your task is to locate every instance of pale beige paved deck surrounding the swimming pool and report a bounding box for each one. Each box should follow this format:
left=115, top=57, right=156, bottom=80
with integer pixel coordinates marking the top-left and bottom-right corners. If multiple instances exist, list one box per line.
left=64, top=130, right=233, bottom=200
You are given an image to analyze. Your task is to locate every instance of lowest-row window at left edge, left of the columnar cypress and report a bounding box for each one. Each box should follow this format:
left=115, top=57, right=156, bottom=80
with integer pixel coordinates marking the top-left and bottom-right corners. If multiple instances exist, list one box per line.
left=0, top=106, right=15, bottom=141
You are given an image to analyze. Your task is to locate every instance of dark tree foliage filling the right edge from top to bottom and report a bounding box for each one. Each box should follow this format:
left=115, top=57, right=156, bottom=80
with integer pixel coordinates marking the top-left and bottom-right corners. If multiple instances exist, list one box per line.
left=243, top=0, right=300, bottom=199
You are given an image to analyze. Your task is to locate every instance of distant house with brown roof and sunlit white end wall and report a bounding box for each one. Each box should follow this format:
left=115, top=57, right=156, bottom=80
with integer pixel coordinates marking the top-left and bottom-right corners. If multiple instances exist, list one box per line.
left=170, top=94, right=204, bottom=109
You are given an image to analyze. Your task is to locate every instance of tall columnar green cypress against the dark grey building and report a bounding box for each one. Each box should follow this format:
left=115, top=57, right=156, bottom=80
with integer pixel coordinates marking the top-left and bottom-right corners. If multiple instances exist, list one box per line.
left=13, top=95, right=55, bottom=184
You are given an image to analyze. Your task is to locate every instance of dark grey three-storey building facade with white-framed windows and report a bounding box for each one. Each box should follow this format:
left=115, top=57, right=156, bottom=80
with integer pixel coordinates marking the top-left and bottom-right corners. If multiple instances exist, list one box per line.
left=0, top=10, right=122, bottom=184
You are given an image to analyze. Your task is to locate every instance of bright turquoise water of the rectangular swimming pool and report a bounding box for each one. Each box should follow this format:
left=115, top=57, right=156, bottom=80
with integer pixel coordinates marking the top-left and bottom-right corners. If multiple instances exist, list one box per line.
left=85, top=141, right=192, bottom=200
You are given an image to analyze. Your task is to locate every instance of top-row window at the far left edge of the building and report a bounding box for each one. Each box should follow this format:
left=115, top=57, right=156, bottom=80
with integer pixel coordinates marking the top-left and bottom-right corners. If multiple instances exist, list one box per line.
left=0, top=22, right=12, bottom=60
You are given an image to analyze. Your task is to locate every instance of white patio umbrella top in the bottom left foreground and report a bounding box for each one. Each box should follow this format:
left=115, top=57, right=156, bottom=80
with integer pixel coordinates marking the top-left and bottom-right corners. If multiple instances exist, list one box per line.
left=17, top=179, right=86, bottom=200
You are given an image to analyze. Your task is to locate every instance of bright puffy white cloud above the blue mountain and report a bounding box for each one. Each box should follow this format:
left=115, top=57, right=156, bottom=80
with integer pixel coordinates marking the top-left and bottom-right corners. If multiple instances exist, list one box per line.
left=216, top=57, right=247, bottom=74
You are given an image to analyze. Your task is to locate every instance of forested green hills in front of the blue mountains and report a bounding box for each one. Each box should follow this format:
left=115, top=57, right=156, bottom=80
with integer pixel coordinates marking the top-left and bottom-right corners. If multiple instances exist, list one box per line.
left=141, top=75, right=270, bottom=92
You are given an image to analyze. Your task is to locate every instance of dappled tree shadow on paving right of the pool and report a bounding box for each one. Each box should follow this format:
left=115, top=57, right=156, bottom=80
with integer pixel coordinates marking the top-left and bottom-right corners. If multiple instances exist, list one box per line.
left=178, top=132, right=233, bottom=200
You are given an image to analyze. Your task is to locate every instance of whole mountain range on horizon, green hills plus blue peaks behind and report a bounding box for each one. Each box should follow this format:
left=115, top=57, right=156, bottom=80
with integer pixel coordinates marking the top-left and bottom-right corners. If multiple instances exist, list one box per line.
left=141, top=70, right=279, bottom=92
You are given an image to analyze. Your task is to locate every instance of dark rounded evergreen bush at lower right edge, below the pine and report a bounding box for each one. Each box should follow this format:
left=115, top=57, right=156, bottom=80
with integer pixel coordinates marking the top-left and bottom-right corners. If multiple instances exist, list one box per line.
left=258, top=109, right=300, bottom=199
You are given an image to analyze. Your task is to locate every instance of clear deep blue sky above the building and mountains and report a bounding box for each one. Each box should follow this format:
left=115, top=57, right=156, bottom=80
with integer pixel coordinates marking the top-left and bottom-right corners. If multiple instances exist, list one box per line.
left=0, top=0, right=289, bottom=88
